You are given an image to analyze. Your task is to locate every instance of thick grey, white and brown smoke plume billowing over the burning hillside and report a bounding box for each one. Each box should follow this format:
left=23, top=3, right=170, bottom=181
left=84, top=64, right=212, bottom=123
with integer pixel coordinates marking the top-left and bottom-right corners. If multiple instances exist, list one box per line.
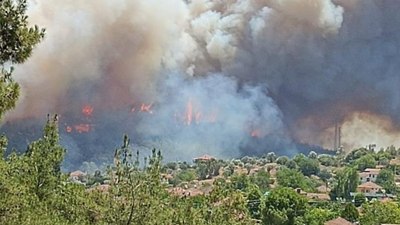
left=4, top=0, right=400, bottom=167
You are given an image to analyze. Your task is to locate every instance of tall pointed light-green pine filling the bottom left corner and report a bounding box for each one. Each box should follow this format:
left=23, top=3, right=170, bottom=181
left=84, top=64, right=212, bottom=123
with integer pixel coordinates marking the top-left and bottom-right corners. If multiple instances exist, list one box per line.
left=0, top=117, right=96, bottom=225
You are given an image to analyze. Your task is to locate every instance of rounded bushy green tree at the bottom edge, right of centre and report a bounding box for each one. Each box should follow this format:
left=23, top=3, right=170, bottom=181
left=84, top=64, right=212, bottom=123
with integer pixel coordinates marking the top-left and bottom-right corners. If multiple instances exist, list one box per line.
left=261, top=188, right=307, bottom=225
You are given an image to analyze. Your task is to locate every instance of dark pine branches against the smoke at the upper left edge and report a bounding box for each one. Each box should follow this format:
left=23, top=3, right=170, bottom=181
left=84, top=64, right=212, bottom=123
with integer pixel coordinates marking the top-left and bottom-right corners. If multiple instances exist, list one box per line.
left=0, top=0, right=45, bottom=119
